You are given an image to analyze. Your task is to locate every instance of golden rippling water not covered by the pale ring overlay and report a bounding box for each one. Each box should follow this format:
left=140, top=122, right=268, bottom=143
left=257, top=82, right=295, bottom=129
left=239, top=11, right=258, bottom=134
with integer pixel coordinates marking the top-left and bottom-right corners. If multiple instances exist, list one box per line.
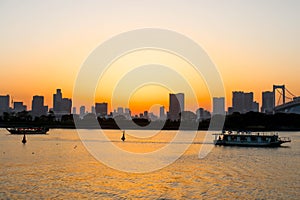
left=0, top=129, right=300, bottom=199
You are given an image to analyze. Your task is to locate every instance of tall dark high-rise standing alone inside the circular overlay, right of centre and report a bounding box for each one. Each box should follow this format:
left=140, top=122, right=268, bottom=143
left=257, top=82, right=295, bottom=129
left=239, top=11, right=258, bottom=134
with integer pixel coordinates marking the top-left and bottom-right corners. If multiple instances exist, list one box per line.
left=168, top=93, right=184, bottom=121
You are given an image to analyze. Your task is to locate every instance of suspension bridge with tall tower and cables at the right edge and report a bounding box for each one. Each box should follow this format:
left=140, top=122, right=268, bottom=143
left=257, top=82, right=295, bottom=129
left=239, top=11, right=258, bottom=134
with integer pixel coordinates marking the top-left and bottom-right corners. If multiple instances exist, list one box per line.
left=273, top=85, right=300, bottom=114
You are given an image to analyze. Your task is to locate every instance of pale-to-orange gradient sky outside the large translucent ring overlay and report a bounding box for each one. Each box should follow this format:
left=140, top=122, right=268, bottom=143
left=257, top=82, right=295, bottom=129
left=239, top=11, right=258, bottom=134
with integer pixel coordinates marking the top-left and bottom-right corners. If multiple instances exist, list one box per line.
left=0, top=0, right=300, bottom=112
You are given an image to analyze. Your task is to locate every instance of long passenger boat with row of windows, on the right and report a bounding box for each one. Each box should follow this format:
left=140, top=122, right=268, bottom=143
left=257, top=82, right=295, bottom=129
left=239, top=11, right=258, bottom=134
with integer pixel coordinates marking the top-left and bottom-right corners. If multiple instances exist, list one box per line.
left=213, top=131, right=291, bottom=147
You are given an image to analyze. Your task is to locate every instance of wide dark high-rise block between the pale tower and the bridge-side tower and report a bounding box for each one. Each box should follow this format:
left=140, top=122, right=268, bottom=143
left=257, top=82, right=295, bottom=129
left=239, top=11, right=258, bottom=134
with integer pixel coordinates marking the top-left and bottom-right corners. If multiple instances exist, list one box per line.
left=231, top=91, right=258, bottom=113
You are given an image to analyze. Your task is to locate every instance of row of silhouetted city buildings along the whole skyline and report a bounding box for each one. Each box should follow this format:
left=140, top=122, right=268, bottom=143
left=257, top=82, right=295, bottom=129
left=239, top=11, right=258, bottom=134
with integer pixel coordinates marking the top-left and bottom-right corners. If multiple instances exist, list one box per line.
left=0, top=86, right=296, bottom=121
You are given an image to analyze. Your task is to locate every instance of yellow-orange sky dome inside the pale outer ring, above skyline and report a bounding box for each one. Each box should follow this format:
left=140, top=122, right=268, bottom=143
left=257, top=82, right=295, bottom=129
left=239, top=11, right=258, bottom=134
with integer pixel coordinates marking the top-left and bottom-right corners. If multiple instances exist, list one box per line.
left=95, top=49, right=211, bottom=114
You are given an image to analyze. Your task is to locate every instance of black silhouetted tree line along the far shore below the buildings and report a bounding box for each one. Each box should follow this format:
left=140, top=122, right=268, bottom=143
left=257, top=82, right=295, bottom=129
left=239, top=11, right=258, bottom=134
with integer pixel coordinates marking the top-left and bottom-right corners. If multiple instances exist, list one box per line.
left=0, top=111, right=300, bottom=131
